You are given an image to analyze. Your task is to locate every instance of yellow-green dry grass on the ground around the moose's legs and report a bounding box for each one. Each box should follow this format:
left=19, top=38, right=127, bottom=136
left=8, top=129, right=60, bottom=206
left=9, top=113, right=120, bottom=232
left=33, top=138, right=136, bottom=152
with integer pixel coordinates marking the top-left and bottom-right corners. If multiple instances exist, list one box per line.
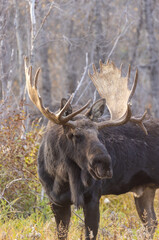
left=0, top=193, right=159, bottom=240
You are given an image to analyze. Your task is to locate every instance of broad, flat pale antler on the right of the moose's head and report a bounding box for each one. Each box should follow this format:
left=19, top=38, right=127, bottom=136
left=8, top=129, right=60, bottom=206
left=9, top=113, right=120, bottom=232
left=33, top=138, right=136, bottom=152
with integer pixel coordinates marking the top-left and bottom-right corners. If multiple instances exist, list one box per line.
left=89, top=60, right=147, bottom=134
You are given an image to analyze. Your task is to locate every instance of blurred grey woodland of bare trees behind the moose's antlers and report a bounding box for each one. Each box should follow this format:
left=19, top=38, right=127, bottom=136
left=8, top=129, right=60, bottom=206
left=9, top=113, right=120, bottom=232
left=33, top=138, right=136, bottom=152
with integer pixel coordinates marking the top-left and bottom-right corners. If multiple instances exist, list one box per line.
left=0, top=0, right=159, bottom=117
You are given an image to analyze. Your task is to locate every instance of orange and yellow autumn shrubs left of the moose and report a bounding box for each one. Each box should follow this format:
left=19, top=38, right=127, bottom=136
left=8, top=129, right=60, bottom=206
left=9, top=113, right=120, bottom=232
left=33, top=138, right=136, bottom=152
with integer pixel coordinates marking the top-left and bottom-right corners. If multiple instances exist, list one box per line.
left=0, top=98, right=41, bottom=213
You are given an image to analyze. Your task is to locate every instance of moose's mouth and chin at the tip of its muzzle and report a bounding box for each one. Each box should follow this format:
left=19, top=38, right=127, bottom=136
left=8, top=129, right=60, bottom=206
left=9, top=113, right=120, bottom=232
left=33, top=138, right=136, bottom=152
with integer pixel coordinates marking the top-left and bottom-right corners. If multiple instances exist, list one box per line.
left=89, top=164, right=113, bottom=180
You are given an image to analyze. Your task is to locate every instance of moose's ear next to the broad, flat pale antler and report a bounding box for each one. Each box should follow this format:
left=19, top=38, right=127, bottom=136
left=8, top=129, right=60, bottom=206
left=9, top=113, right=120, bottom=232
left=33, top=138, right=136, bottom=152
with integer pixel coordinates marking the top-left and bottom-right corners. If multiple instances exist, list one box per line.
left=86, top=98, right=106, bottom=121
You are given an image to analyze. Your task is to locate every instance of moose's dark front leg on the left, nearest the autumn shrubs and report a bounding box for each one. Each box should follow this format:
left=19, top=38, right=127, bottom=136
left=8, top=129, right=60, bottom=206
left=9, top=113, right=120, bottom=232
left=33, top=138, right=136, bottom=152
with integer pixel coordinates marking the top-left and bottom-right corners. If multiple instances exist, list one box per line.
left=51, top=204, right=71, bottom=240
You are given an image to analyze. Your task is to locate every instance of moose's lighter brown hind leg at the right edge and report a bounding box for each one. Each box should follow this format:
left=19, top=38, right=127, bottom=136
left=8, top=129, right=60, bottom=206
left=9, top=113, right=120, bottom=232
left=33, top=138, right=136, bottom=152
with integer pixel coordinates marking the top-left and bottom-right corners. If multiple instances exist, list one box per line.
left=134, top=187, right=157, bottom=238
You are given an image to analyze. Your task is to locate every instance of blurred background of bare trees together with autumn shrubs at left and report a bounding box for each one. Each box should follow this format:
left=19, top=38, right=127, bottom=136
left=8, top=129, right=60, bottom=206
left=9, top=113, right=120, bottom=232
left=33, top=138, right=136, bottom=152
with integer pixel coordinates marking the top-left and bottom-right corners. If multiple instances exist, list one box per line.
left=0, top=0, right=159, bottom=231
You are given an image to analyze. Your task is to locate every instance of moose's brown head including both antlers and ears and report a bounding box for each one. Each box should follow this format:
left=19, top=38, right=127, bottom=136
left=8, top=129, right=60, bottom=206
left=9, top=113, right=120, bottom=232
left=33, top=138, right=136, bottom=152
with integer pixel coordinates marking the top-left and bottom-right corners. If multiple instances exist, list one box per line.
left=25, top=58, right=146, bottom=185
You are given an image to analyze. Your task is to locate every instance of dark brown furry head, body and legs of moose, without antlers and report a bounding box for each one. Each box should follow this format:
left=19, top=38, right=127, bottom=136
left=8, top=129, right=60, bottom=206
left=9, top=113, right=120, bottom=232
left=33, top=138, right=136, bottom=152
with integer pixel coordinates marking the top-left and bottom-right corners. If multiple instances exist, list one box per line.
left=38, top=100, right=159, bottom=239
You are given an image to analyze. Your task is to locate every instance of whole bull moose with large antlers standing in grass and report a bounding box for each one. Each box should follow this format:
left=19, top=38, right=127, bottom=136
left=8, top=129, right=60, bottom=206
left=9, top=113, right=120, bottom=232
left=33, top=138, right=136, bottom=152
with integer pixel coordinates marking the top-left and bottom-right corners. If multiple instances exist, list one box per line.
left=25, top=59, right=159, bottom=240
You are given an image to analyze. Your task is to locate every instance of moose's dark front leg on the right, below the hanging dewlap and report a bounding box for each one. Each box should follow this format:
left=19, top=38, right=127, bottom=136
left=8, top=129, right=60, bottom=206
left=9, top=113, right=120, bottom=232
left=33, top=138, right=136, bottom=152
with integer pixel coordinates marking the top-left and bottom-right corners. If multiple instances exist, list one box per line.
left=83, top=199, right=100, bottom=240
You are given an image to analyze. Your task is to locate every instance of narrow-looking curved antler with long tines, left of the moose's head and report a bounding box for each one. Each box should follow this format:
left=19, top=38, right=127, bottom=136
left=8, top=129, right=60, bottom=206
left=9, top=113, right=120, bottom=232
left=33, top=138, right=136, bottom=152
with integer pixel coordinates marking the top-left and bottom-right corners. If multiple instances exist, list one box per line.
left=24, top=57, right=90, bottom=127
